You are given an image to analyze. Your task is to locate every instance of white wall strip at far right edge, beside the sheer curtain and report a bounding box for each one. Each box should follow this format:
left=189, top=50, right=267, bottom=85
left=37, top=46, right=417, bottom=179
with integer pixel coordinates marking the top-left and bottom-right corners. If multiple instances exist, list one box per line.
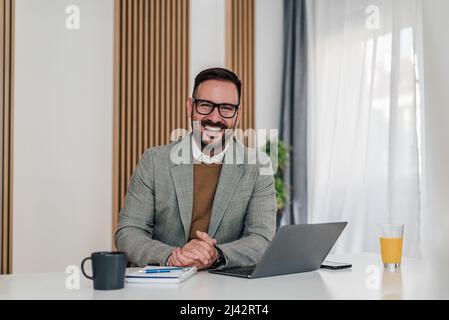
left=423, top=0, right=449, bottom=294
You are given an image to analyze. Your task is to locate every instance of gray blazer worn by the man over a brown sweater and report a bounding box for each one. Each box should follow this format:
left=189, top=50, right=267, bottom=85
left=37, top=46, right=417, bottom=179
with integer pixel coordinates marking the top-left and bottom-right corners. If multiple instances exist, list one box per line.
left=115, top=134, right=276, bottom=268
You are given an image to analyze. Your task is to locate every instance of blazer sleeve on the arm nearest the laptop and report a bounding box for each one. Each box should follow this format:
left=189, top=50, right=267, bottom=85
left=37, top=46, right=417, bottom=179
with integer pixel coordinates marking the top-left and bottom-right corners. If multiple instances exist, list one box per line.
left=216, top=159, right=276, bottom=269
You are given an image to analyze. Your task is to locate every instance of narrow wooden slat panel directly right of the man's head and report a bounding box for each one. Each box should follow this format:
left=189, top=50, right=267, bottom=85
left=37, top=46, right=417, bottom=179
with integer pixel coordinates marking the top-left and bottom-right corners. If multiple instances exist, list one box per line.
left=226, top=0, right=255, bottom=141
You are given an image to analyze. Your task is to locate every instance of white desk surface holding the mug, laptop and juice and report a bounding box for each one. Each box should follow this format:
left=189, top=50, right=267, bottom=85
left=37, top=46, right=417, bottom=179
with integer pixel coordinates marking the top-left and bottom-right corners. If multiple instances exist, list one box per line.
left=0, top=253, right=442, bottom=300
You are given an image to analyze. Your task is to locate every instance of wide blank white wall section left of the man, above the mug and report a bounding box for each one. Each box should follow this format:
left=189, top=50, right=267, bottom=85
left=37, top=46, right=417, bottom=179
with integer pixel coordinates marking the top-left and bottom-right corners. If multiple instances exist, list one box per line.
left=13, top=0, right=114, bottom=273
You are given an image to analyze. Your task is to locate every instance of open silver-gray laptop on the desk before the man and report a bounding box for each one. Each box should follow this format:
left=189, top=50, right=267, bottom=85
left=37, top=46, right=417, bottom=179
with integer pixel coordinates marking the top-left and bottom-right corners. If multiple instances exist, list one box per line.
left=209, top=222, right=348, bottom=279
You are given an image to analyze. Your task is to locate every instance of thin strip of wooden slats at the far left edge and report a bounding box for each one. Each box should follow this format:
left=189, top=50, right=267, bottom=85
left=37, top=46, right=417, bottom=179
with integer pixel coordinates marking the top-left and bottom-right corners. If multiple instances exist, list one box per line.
left=0, top=0, right=14, bottom=274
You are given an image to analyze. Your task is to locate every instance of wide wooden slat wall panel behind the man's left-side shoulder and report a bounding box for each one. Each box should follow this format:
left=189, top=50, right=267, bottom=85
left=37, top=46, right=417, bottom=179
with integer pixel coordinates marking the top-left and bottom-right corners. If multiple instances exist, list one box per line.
left=112, top=0, right=190, bottom=239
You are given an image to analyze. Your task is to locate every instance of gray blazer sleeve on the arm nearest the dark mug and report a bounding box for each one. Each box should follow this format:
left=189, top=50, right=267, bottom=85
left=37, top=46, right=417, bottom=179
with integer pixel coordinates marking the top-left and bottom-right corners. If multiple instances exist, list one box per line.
left=115, top=149, right=175, bottom=267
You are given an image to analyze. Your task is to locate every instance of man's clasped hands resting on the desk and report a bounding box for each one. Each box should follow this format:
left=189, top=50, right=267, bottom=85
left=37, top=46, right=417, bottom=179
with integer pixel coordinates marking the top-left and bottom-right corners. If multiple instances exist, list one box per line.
left=167, top=231, right=218, bottom=270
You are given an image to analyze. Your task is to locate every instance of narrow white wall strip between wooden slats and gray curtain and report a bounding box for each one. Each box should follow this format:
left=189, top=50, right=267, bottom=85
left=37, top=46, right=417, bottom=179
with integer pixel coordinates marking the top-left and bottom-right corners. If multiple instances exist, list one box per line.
left=256, top=0, right=284, bottom=129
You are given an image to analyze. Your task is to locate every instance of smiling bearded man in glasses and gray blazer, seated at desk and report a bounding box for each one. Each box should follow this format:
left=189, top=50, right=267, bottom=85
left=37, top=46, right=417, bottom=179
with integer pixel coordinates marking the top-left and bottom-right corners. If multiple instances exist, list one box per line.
left=115, top=68, right=276, bottom=269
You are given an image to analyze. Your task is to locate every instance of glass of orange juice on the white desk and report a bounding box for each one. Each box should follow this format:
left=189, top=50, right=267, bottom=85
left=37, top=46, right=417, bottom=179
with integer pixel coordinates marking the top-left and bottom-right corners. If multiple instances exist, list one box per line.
left=379, top=224, right=404, bottom=270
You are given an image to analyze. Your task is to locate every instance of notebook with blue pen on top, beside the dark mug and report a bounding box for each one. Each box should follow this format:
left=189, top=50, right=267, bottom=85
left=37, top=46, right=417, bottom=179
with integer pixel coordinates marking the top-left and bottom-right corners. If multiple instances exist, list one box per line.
left=125, top=266, right=197, bottom=283
